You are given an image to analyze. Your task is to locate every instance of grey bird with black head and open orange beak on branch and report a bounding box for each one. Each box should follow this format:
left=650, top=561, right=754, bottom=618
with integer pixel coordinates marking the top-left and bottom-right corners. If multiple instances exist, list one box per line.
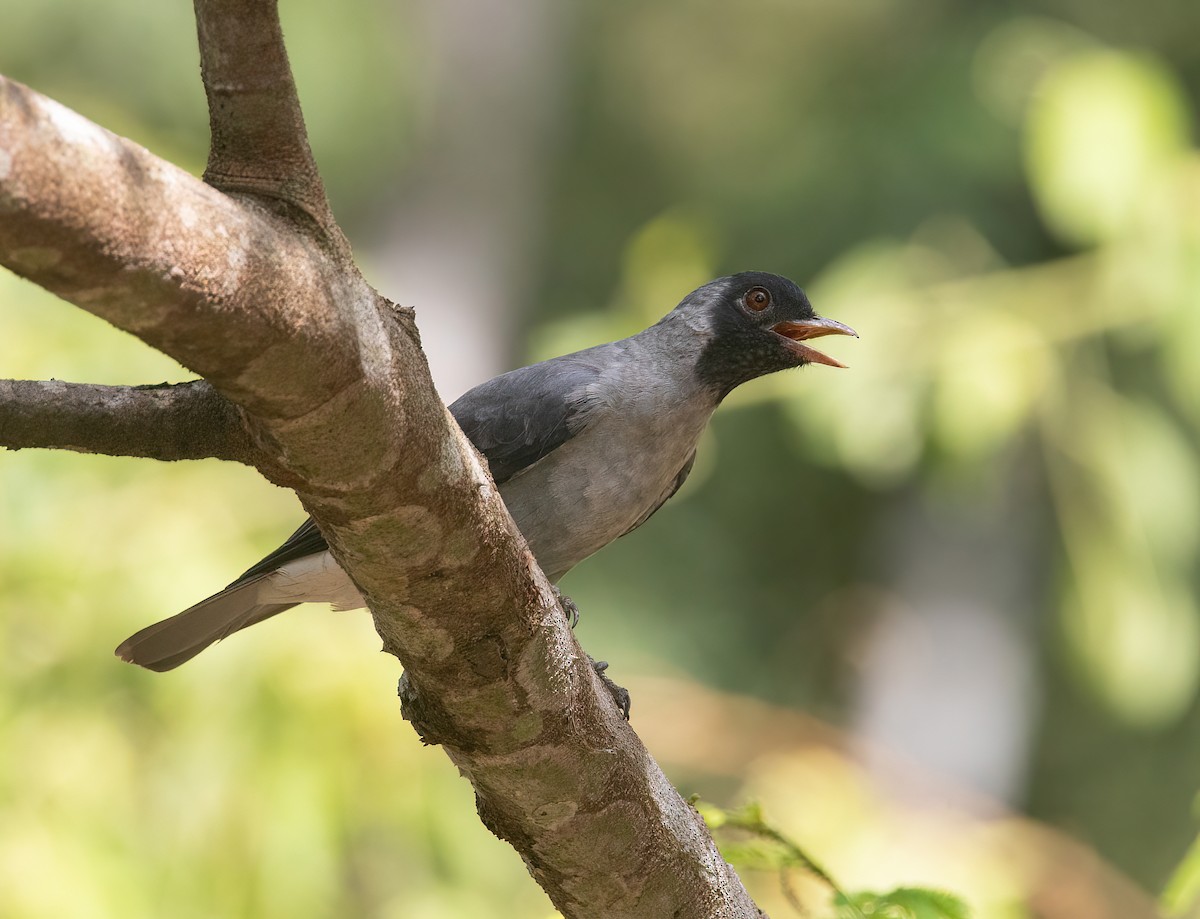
left=116, top=271, right=857, bottom=671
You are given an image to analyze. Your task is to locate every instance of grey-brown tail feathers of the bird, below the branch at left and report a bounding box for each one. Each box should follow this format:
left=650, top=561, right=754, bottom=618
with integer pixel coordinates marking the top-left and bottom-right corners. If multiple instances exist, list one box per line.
left=116, top=575, right=296, bottom=673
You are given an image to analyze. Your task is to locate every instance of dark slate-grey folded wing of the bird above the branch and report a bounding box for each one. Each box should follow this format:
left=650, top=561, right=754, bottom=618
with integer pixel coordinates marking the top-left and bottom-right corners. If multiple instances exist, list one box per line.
left=450, top=346, right=611, bottom=485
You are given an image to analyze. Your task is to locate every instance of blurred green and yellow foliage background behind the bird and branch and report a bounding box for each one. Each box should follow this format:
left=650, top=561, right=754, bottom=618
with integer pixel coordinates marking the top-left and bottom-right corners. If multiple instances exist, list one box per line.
left=0, top=0, right=1200, bottom=919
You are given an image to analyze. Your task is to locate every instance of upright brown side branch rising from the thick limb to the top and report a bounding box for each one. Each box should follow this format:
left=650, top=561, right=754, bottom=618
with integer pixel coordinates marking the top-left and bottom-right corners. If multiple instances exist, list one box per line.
left=194, top=0, right=348, bottom=251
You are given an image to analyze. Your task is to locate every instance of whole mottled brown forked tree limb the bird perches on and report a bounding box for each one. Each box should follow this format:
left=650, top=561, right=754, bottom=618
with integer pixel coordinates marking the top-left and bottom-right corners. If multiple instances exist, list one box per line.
left=0, top=0, right=760, bottom=919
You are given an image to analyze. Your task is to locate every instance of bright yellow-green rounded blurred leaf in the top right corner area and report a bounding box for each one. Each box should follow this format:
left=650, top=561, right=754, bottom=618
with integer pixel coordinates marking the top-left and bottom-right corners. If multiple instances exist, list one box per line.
left=1025, top=52, right=1189, bottom=246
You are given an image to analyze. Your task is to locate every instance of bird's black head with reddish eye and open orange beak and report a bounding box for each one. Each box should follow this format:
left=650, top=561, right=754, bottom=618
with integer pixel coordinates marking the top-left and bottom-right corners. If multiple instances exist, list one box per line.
left=674, top=271, right=858, bottom=396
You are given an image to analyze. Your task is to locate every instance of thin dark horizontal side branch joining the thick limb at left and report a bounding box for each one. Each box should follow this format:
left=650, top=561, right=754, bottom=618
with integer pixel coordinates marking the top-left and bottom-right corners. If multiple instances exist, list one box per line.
left=0, top=380, right=264, bottom=465
